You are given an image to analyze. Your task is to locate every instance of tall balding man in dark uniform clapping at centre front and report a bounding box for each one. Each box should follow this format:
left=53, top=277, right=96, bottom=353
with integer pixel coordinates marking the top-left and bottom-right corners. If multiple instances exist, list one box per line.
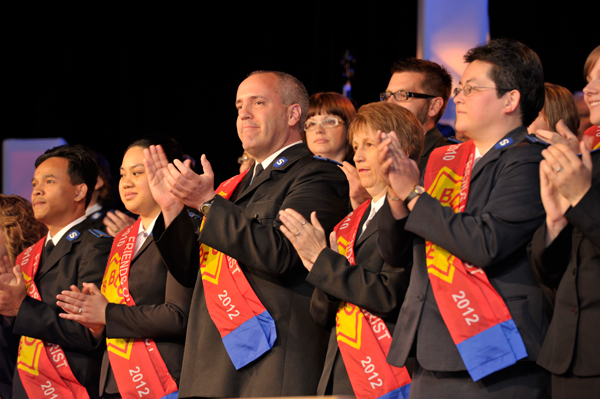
left=146, top=71, right=348, bottom=398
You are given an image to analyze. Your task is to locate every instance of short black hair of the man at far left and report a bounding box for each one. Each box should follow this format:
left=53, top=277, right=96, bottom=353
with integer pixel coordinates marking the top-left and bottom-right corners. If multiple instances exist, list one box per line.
left=35, top=144, right=98, bottom=208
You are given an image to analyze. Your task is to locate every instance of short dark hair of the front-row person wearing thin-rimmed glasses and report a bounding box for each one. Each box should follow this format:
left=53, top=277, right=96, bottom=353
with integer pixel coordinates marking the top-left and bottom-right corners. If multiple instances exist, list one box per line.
left=464, top=38, right=544, bottom=126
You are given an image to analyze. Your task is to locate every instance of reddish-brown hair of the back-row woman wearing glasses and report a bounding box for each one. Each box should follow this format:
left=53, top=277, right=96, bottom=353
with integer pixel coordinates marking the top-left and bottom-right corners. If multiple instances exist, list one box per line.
left=300, top=92, right=356, bottom=162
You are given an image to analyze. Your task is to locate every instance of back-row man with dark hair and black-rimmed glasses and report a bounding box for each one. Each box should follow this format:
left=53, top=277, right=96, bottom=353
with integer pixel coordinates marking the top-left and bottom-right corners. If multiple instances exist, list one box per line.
left=379, top=58, right=452, bottom=173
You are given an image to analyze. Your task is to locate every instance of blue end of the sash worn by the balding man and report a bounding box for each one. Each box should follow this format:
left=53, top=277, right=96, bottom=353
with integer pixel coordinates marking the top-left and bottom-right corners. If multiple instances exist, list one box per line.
left=223, top=310, right=277, bottom=370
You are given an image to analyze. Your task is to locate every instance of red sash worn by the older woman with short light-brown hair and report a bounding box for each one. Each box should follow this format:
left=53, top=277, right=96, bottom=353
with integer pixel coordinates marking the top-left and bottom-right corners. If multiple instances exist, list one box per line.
left=335, top=201, right=411, bottom=399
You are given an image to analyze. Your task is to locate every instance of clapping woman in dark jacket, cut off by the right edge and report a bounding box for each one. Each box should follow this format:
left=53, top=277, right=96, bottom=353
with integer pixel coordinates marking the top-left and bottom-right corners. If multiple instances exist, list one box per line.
left=530, top=46, right=600, bottom=398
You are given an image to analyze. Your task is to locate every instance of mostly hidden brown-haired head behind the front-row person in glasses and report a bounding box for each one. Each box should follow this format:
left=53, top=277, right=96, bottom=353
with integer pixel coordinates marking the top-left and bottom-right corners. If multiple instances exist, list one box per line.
left=527, top=83, right=579, bottom=138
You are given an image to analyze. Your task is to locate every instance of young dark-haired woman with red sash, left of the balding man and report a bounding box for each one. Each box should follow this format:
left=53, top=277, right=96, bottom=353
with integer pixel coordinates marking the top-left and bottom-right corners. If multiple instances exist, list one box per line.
left=57, top=137, right=192, bottom=398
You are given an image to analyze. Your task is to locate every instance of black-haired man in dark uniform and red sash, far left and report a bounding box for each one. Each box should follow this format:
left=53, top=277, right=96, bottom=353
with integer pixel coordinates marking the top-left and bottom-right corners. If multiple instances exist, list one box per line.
left=0, top=146, right=112, bottom=398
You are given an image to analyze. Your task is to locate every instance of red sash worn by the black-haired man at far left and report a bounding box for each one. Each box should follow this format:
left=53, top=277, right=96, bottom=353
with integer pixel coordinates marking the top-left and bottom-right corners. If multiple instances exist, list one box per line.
left=16, top=237, right=89, bottom=399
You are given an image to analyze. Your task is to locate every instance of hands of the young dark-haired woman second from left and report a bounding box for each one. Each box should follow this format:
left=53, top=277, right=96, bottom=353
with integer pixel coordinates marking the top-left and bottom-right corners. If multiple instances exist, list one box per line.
left=56, top=283, right=108, bottom=338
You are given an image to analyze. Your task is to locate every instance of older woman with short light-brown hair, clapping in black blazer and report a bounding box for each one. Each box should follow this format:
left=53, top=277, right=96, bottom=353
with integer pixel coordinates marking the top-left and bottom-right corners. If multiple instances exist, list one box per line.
left=280, top=102, right=423, bottom=398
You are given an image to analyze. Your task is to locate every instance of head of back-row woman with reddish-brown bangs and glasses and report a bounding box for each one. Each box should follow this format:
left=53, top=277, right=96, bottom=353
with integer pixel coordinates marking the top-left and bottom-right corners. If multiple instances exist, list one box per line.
left=302, top=92, right=356, bottom=164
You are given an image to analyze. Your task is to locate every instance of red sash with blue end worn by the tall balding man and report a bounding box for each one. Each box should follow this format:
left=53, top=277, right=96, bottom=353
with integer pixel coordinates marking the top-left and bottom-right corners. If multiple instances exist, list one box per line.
left=200, top=171, right=277, bottom=370
